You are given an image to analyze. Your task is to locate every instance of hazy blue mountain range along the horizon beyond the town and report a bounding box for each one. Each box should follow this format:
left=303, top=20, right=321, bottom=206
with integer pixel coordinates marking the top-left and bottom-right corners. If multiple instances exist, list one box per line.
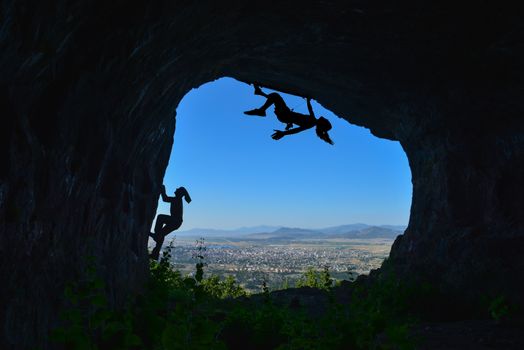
left=175, top=223, right=406, bottom=240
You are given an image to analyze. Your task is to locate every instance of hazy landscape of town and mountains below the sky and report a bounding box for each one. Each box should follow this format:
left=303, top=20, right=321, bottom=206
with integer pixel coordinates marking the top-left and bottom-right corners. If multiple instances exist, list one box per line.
left=151, top=225, right=402, bottom=293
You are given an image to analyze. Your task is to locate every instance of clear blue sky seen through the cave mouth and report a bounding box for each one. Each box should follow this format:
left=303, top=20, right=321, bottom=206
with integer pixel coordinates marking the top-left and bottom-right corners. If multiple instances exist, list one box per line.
left=158, top=78, right=412, bottom=230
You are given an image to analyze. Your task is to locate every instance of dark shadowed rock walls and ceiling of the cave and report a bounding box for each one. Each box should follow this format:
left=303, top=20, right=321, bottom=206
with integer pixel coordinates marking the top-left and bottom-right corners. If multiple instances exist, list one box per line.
left=0, top=0, right=524, bottom=349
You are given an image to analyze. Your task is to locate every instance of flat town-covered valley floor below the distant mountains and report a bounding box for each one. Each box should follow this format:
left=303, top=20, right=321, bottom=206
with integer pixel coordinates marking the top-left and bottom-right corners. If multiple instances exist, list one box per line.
left=160, top=237, right=393, bottom=293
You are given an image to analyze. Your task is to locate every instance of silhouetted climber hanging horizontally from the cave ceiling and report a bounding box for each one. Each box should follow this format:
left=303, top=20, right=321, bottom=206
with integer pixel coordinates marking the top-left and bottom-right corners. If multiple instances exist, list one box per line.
left=244, top=84, right=333, bottom=145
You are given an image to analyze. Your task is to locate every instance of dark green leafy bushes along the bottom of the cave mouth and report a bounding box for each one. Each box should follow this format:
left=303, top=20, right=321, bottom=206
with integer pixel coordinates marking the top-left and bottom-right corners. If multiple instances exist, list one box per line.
left=51, top=243, right=488, bottom=350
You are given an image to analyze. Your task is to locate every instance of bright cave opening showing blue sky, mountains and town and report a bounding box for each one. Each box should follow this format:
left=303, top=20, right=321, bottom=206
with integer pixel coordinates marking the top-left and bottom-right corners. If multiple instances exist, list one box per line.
left=148, top=78, right=412, bottom=287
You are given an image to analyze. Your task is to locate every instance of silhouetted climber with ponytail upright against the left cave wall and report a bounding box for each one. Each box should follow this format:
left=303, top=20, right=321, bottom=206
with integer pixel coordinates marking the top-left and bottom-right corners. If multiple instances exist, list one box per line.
left=149, top=185, right=191, bottom=260
